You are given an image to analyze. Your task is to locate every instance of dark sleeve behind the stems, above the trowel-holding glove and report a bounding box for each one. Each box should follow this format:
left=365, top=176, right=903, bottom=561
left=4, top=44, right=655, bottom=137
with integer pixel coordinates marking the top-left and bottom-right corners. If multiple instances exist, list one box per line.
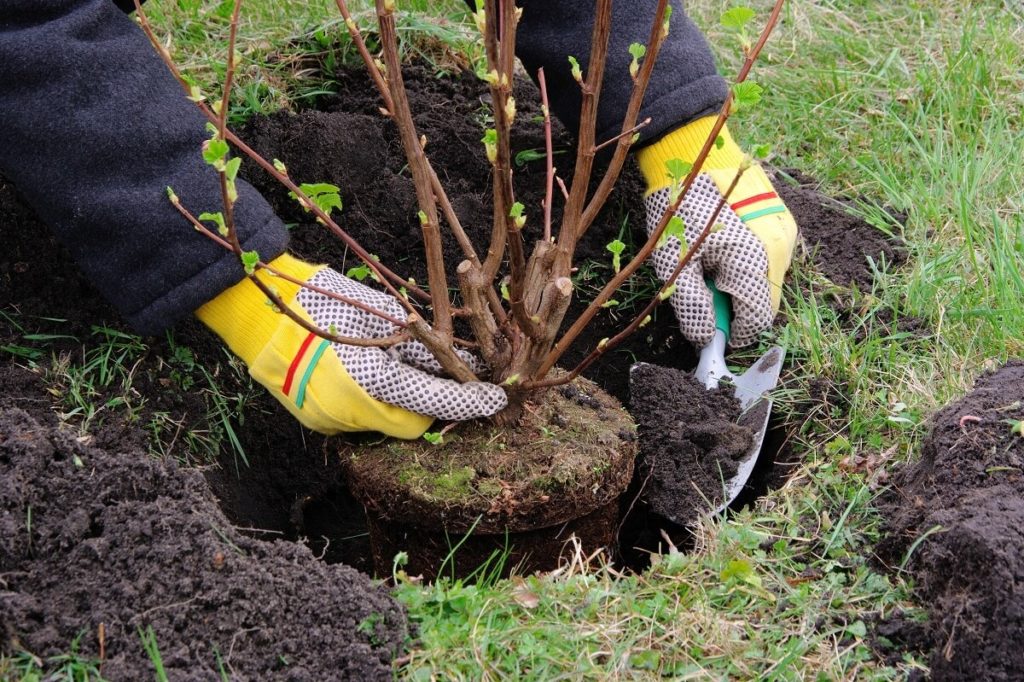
left=467, top=0, right=728, bottom=142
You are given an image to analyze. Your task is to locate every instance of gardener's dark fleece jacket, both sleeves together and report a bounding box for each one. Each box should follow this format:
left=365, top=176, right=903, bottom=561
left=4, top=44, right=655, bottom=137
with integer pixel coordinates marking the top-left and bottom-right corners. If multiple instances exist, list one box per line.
left=0, top=0, right=726, bottom=333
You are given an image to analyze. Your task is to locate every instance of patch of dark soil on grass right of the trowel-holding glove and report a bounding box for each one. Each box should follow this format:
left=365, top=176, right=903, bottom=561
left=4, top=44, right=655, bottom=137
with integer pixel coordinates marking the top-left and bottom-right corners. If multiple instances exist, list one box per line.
left=775, top=169, right=906, bottom=291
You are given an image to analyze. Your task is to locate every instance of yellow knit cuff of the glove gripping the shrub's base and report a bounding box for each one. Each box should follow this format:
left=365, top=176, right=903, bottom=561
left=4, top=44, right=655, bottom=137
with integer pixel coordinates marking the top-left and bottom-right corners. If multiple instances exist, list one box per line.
left=196, top=253, right=324, bottom=365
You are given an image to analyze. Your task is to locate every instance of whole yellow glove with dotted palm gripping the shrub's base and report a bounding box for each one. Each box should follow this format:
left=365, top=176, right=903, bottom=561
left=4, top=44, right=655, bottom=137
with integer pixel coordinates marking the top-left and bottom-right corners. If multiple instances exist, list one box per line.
left=196, top=254, right=507, bottom=438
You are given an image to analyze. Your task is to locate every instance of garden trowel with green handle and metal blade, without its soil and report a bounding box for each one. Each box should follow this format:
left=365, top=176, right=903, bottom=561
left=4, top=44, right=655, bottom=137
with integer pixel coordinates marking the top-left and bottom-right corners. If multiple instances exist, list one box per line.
left=693, top=280, right=785, bottom=514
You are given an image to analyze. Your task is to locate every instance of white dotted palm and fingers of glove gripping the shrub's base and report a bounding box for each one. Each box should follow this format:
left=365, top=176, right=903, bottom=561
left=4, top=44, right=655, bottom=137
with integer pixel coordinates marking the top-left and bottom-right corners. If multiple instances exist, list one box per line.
left=296, top=267, right=508, bottom=421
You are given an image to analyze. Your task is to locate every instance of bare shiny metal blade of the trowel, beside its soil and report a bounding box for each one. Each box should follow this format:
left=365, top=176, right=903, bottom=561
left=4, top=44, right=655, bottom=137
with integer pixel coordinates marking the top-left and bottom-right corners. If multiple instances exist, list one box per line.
left=714, top=346, right=785, bottom=514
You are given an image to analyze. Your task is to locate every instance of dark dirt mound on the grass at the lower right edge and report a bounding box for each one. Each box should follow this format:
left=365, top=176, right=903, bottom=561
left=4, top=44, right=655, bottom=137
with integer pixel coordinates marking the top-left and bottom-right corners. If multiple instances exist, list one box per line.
left=878, top=360, right=1024, bottom=680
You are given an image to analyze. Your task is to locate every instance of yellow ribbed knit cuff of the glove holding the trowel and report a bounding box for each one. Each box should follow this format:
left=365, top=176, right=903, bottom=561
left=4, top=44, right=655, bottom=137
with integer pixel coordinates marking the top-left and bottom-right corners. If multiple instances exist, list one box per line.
left=637, top=116, right=743, bottom=194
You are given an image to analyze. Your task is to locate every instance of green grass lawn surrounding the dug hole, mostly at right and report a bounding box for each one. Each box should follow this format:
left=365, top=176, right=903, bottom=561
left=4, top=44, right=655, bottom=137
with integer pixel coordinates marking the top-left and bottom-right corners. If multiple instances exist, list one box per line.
left=9, top=0, right=1024, bottom=680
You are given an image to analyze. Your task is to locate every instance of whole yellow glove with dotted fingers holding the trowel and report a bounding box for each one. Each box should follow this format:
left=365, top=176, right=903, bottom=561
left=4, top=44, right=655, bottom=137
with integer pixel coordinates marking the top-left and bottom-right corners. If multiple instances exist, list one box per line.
left=637, top=116, right=797, bottom=347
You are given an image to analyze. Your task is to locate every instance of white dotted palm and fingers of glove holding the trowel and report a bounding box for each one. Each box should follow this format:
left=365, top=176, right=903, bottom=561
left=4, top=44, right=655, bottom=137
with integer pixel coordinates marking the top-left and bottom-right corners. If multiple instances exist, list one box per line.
left=646, top=174, right=774, bottom=347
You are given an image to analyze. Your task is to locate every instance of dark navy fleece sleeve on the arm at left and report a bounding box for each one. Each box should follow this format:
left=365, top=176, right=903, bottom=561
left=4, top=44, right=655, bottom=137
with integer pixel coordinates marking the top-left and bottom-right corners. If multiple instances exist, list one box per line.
left=0, top=0, right=287, bottom=333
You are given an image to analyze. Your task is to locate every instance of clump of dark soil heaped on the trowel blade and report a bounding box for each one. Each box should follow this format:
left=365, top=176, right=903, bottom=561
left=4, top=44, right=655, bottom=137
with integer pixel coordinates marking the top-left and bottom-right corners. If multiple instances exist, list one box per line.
left=630, top=364, right=754, bottom=525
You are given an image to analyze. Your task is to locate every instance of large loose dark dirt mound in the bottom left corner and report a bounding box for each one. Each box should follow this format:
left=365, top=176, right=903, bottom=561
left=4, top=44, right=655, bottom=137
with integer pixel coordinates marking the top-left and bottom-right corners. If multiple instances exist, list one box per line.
left=0, top=410, right=407, bottom=680
